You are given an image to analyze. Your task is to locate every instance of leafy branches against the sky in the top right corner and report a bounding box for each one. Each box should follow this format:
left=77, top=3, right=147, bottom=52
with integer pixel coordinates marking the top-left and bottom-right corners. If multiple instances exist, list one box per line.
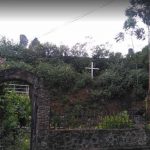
left=115, top=0, right=150, bottom=42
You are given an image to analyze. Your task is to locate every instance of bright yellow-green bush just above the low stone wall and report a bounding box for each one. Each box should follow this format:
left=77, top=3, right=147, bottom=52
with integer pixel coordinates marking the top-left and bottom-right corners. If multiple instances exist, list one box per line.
left=97, top=111, right=132, bottom=129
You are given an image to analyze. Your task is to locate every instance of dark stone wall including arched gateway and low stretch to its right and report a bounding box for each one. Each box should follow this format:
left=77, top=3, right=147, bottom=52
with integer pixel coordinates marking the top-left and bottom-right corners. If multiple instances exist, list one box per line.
left=0, top=69, right=150, bottom=150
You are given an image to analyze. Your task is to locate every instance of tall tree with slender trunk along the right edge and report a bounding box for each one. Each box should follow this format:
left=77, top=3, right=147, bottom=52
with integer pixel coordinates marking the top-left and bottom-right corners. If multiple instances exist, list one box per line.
left=125, top=0, right=150, bottom=95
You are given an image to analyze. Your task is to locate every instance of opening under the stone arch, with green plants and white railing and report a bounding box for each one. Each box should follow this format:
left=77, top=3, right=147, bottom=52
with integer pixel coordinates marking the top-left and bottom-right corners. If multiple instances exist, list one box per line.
left=0, top=80, right=32, bottom=150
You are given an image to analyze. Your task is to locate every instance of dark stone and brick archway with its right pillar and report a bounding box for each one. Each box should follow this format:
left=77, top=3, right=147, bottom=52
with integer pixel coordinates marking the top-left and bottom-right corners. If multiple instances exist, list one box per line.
left=0, top=69, right=50, bottom=150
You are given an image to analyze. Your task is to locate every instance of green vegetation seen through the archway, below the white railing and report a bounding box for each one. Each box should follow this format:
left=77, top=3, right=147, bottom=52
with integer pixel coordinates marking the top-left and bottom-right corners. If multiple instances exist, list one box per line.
left=0, top=92, right=31, bottom=150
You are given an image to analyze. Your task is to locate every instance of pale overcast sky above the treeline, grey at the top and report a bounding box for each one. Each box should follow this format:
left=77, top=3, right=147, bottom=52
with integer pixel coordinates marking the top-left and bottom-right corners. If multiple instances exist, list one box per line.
left=0, top=0, right=147, bottom=54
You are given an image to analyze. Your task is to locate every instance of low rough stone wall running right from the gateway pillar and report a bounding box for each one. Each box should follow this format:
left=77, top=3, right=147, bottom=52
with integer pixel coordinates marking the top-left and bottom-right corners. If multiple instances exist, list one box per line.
left=47, top=129, right=150, bottom=150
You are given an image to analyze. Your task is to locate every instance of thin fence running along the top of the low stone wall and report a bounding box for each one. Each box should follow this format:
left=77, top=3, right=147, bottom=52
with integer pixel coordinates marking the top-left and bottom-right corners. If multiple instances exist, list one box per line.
left=50, top=111, right=146, bottom=129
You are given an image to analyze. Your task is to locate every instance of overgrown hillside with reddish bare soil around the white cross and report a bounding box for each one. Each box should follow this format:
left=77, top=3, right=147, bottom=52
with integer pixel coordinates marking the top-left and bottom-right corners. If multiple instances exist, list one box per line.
left=0, top=39, right=148, bottom=127
